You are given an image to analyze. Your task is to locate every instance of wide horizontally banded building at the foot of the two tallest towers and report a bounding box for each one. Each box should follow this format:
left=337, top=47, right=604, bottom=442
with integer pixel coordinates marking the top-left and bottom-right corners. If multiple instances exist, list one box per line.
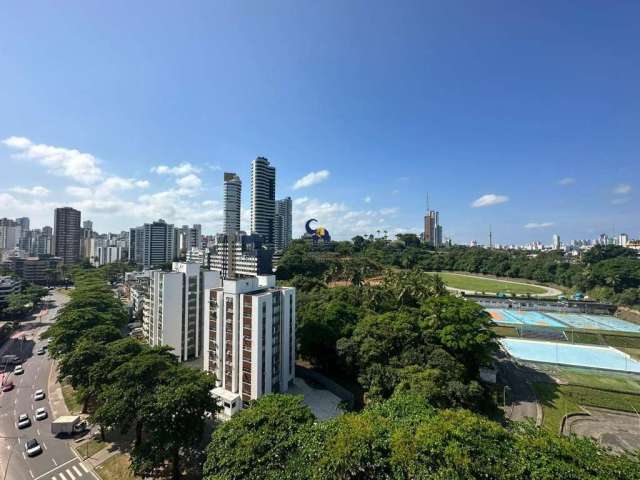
left=209, top=232, right=273, bottom=279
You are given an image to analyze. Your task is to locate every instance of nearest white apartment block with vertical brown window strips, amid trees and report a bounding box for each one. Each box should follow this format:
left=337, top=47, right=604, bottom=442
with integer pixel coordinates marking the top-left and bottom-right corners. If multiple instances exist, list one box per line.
left=204, top=275, right=296, bottom=417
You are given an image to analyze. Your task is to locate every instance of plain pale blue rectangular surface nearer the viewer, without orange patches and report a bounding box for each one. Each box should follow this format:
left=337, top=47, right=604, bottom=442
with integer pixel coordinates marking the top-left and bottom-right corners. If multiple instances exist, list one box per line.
left=500, top=338, right=640, bottom=373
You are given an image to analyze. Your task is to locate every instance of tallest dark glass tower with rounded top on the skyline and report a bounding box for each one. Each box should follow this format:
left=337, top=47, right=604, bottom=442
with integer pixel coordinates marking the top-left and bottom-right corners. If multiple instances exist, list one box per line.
left=251, top=157, right=276, bottom=246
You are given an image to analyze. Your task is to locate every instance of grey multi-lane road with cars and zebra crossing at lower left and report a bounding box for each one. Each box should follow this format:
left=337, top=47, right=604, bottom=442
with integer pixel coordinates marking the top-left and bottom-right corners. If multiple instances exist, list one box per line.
left=0, top=292, right=95, bottom=480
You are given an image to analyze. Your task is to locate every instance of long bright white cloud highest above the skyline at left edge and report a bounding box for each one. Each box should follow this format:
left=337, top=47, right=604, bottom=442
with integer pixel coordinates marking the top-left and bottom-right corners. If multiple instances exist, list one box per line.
left=2, top=137, right=103, bottom=184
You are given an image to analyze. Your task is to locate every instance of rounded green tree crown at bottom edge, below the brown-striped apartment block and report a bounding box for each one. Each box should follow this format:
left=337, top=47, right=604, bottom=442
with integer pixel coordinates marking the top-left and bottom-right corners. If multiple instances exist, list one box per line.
left=204, top=394, right=314, bottom=480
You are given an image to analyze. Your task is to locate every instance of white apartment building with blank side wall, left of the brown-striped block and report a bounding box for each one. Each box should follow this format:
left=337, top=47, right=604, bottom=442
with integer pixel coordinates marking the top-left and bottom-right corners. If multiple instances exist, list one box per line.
left=142, top=262, right=221, bottom=361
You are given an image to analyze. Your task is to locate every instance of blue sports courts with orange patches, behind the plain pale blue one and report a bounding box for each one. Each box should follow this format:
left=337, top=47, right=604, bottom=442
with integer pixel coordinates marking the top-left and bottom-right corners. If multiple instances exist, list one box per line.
left=487, top=308, right=640, bottom=333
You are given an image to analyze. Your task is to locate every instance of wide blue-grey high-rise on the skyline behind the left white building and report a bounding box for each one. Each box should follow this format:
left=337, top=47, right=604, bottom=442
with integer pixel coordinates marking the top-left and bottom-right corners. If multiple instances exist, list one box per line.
left=128, top=219, right=176, bottom=268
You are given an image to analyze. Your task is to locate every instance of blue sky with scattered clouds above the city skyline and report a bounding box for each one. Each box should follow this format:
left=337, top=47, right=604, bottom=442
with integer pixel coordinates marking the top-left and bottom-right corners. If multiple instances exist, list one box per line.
left=0, top=1, right=640, bottom=243
